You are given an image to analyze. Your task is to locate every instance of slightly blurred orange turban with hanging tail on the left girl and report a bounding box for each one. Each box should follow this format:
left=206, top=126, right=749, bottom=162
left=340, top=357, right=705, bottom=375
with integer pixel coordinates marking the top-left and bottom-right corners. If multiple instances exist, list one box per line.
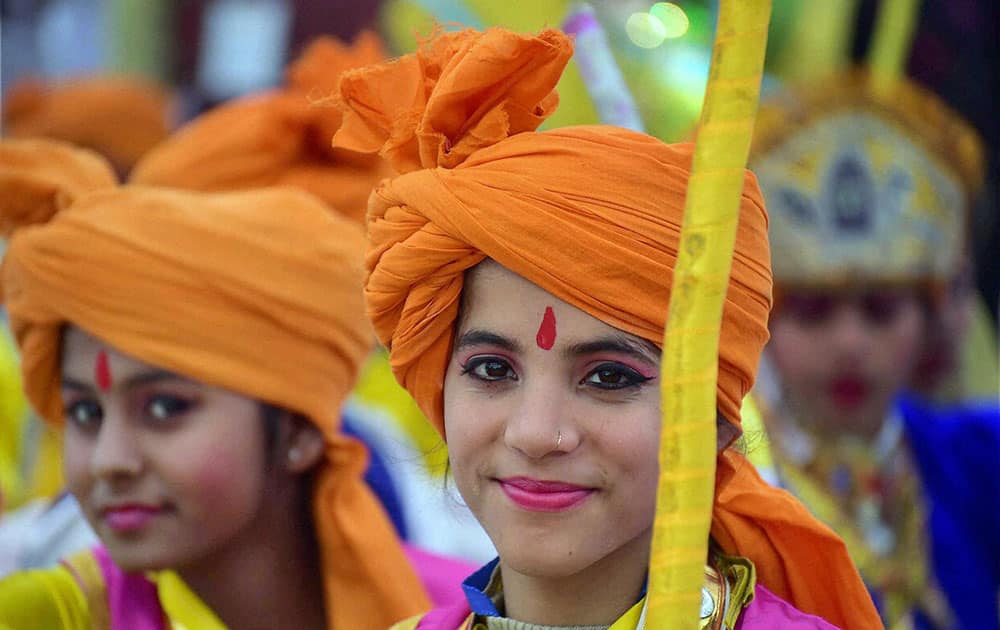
left=0, top=141, right=429, bottom=630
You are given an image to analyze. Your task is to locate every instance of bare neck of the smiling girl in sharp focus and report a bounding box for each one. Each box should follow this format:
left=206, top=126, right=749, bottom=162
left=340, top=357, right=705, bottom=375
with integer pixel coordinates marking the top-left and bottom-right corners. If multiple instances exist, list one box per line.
left=500, top=529, right=652, bottom=626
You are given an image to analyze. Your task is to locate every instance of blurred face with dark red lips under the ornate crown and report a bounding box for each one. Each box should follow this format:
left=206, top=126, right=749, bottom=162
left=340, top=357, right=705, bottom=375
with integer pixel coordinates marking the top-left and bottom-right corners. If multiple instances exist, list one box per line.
left=768, top=288, right=925, bottom=435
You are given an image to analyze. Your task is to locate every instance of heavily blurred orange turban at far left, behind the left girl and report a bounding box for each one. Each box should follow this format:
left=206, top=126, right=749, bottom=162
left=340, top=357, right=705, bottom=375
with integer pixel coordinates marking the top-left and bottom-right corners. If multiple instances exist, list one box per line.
left=3, top=77, right=170, bottom=173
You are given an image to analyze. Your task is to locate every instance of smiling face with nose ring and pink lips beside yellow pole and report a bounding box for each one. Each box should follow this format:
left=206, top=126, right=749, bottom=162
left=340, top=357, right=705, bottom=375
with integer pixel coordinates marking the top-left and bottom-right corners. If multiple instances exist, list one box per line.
left=444, top=262, right=660, bottom=577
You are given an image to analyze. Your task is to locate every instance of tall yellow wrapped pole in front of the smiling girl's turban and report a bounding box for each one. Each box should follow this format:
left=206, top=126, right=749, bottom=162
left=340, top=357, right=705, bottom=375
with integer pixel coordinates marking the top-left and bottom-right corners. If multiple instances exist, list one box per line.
left=646, top=0, right=771, bottom=630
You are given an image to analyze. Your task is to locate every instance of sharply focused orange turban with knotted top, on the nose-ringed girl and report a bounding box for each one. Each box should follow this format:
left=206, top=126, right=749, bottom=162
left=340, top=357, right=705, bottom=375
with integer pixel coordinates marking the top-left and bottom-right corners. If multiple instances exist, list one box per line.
left=334, top=29, right=879, bottom=628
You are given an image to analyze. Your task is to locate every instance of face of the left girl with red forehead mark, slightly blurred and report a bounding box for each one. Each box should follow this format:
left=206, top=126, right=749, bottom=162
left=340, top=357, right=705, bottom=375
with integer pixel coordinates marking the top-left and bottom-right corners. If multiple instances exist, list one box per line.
left=62, top=328, right=267, bottom=570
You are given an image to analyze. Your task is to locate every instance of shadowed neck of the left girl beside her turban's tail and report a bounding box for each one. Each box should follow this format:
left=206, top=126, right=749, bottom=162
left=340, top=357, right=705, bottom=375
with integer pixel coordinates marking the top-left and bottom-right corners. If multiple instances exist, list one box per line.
left=178, top=484, right=326, bottom=630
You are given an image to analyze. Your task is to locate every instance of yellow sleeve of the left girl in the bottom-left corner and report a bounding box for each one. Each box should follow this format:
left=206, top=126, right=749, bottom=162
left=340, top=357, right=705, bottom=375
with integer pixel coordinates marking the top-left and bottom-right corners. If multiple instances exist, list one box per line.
left=0, top=566, right=91, bottom=630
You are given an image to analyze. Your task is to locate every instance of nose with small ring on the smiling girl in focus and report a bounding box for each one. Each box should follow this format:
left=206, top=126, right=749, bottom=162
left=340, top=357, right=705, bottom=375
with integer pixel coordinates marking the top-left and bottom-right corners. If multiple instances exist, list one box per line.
left=504, top=381, right=581, bottom=459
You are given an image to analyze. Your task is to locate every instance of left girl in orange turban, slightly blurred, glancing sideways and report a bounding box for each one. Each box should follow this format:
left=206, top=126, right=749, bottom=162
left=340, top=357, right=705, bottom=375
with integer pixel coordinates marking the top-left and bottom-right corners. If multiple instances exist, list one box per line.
left=0, top=141, right=429, bottom=630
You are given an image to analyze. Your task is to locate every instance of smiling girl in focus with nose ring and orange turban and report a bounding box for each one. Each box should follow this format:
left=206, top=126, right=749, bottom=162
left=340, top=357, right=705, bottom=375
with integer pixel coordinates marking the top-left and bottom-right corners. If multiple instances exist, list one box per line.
left=334, top=29, right=878, bottom=630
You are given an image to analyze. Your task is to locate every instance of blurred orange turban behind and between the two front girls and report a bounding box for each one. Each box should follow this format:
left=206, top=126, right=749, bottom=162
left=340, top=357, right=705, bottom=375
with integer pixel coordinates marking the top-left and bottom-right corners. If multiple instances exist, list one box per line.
left=130, top=33, right=390, bottom=221
